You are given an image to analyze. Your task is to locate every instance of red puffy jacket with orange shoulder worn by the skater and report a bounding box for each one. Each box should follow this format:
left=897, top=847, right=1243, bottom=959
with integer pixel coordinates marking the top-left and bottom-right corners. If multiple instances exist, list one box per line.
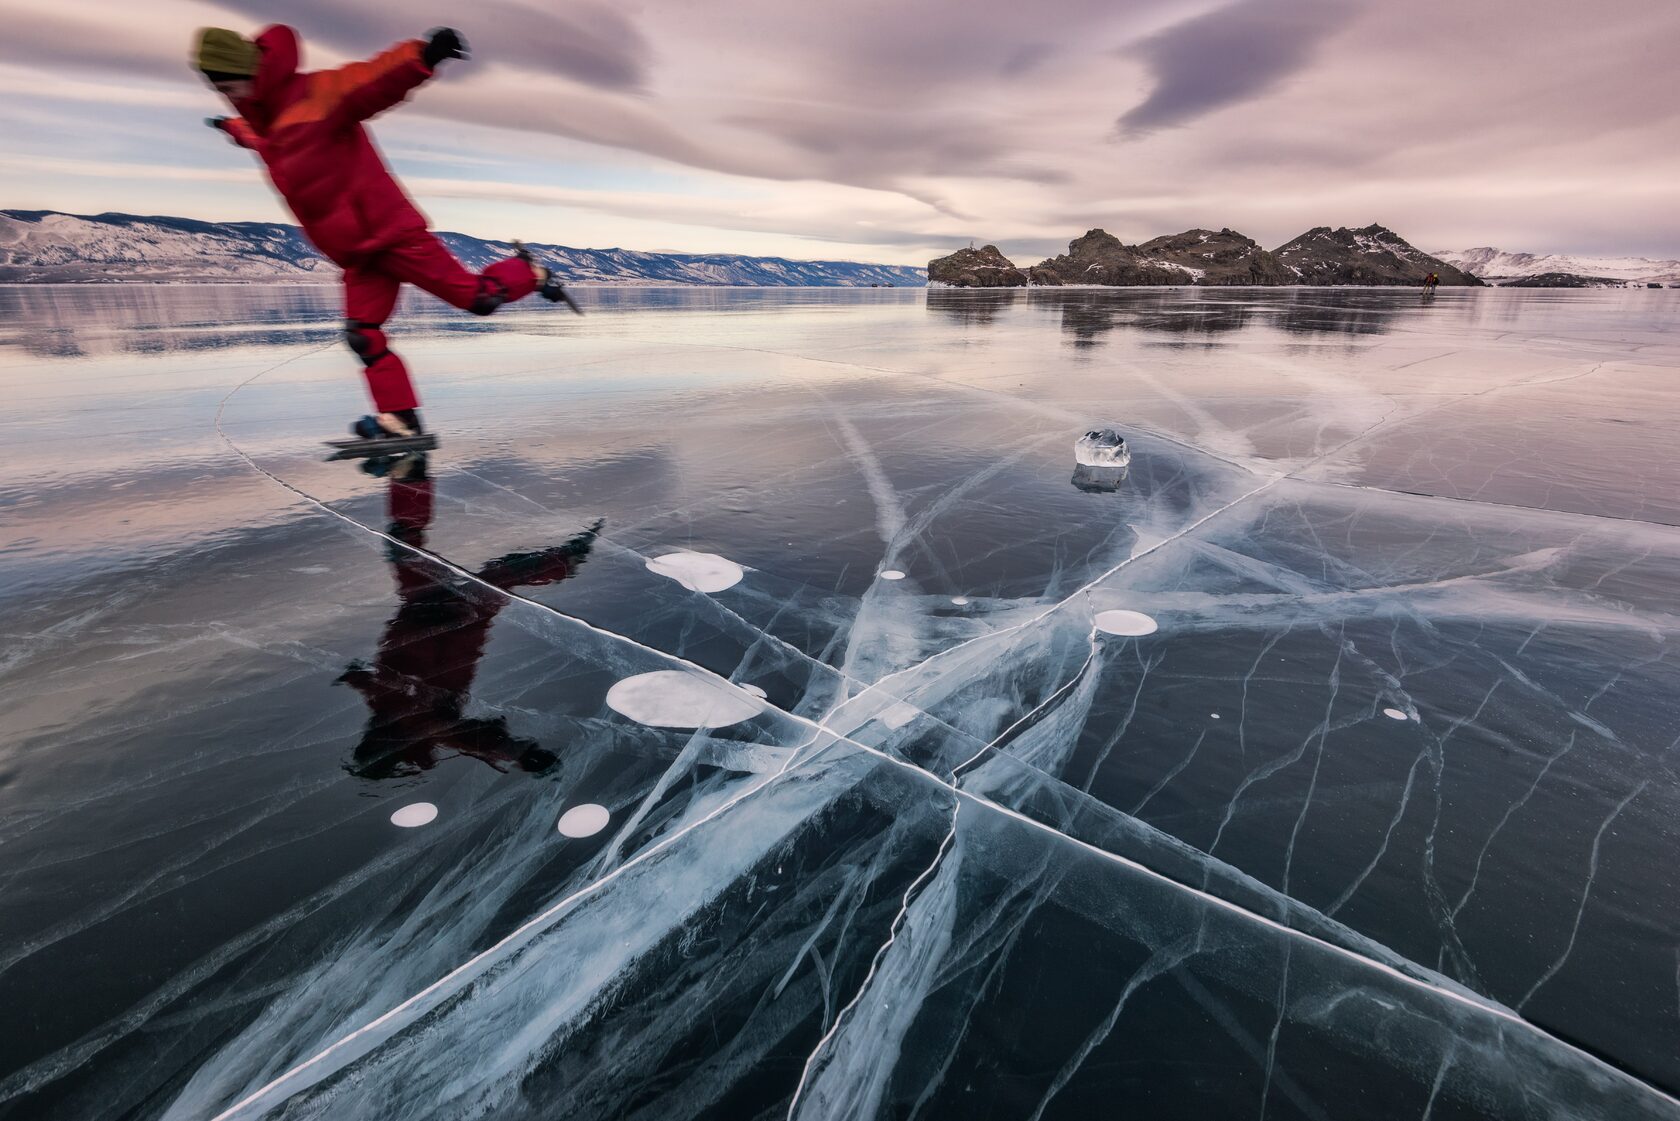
left=223, top=25, right=432, bottom=267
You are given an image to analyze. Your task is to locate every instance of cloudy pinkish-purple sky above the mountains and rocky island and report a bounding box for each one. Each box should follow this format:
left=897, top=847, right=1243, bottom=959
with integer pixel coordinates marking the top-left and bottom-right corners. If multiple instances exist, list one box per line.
left=0, top=0, right=1680, bottom=264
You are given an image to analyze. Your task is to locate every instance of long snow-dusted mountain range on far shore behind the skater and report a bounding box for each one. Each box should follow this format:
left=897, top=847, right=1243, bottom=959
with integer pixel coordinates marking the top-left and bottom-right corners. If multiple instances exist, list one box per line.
left=0, top=210, right=926, bottom=287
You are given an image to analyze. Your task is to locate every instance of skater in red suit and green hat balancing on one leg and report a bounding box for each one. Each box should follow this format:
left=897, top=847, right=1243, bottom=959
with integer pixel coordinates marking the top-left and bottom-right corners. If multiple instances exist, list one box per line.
left=193, top=25, right=576, bottom=454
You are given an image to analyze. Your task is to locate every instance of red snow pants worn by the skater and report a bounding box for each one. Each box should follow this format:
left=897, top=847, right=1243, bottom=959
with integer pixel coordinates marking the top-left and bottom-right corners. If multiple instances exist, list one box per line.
left=344, top=230, right=536, bottom=412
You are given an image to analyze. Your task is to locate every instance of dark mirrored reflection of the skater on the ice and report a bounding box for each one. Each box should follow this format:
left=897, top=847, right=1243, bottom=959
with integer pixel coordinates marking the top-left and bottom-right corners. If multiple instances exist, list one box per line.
left=339, top=455, right=600, bottom=778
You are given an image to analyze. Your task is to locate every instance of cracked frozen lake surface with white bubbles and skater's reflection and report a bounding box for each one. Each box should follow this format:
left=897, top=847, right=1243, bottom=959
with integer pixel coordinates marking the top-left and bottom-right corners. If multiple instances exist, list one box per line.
left=0, top=287, right=1680, bottom=1121
